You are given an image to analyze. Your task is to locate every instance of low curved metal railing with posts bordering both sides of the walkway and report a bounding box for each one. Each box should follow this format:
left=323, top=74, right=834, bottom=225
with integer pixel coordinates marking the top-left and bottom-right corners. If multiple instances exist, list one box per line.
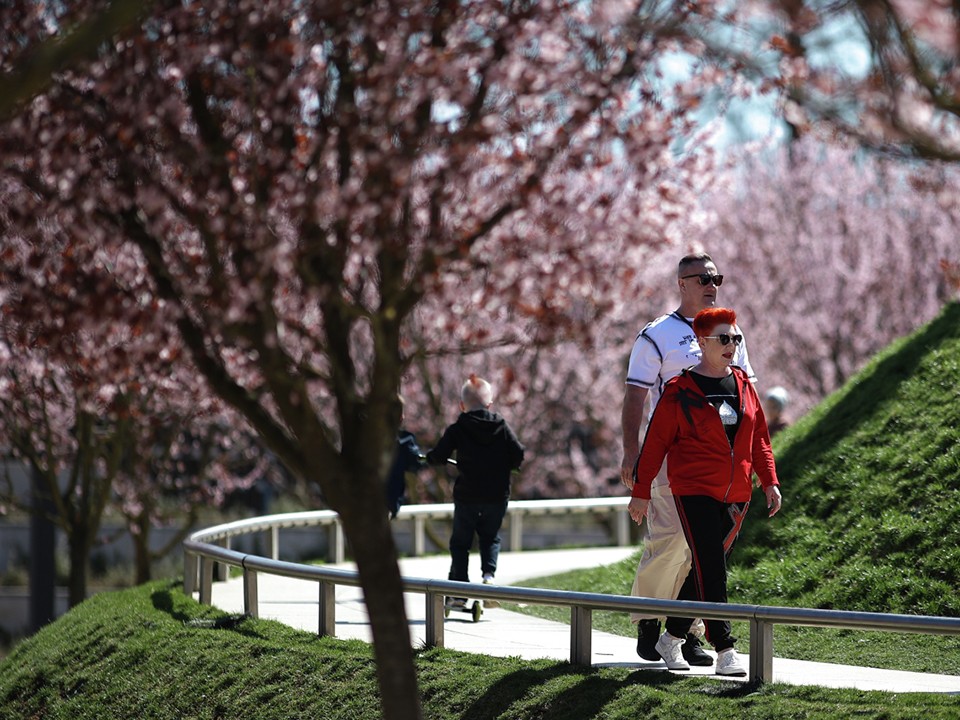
left=183, top=497, right=960, bottom=682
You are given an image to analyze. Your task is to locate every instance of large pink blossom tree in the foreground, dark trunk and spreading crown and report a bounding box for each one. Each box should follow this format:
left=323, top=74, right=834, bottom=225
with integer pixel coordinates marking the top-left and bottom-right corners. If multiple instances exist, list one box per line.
left=0, top=2, right=736, bottom=718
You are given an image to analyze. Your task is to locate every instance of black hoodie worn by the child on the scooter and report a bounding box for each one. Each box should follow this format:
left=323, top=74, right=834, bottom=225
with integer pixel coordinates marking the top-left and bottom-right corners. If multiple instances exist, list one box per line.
left=427, top=410, right=524, bottom=502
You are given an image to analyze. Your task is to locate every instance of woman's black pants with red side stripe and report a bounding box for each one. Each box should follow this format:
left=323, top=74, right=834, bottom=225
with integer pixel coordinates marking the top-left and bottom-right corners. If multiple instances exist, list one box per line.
left=667, top=495, right=750, bottom=652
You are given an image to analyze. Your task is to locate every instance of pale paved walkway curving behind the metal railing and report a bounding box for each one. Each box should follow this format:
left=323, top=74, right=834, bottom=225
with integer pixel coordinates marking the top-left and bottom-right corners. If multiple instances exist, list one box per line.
left=204, top=547, right=960, bottom=695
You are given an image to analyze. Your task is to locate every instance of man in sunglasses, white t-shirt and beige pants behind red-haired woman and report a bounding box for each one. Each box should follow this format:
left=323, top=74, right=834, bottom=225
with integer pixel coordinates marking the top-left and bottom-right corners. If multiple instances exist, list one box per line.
left=620, top=253, right=756, bottom=666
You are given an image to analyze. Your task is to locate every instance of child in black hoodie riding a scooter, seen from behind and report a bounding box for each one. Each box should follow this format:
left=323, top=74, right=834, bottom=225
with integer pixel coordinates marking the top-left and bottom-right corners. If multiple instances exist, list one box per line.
left=427, top=375, right=524, bottom=606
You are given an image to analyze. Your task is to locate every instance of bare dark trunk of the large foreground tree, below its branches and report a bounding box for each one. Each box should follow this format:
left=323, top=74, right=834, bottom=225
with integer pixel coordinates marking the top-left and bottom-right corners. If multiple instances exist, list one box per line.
left=340, top=501, right=423, bottom=720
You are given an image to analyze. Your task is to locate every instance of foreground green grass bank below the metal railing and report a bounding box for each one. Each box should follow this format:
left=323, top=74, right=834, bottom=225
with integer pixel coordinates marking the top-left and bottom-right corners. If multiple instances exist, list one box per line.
left=0, top=581, right=960, bottom=720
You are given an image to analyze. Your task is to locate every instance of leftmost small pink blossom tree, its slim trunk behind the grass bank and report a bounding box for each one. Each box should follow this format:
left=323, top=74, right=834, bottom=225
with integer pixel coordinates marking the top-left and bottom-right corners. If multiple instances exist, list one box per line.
left=0, top=215, right=197, bottom=605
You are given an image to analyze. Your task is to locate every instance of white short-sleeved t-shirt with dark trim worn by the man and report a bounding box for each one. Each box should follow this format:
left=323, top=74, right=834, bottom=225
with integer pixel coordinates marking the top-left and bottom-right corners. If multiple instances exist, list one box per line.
left=627, top=311, right=757, bottom=420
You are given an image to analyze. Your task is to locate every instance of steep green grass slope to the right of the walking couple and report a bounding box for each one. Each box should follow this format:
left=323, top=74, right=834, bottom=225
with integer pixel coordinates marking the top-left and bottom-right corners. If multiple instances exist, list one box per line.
left=731, top=303, right=960, bottom=616
